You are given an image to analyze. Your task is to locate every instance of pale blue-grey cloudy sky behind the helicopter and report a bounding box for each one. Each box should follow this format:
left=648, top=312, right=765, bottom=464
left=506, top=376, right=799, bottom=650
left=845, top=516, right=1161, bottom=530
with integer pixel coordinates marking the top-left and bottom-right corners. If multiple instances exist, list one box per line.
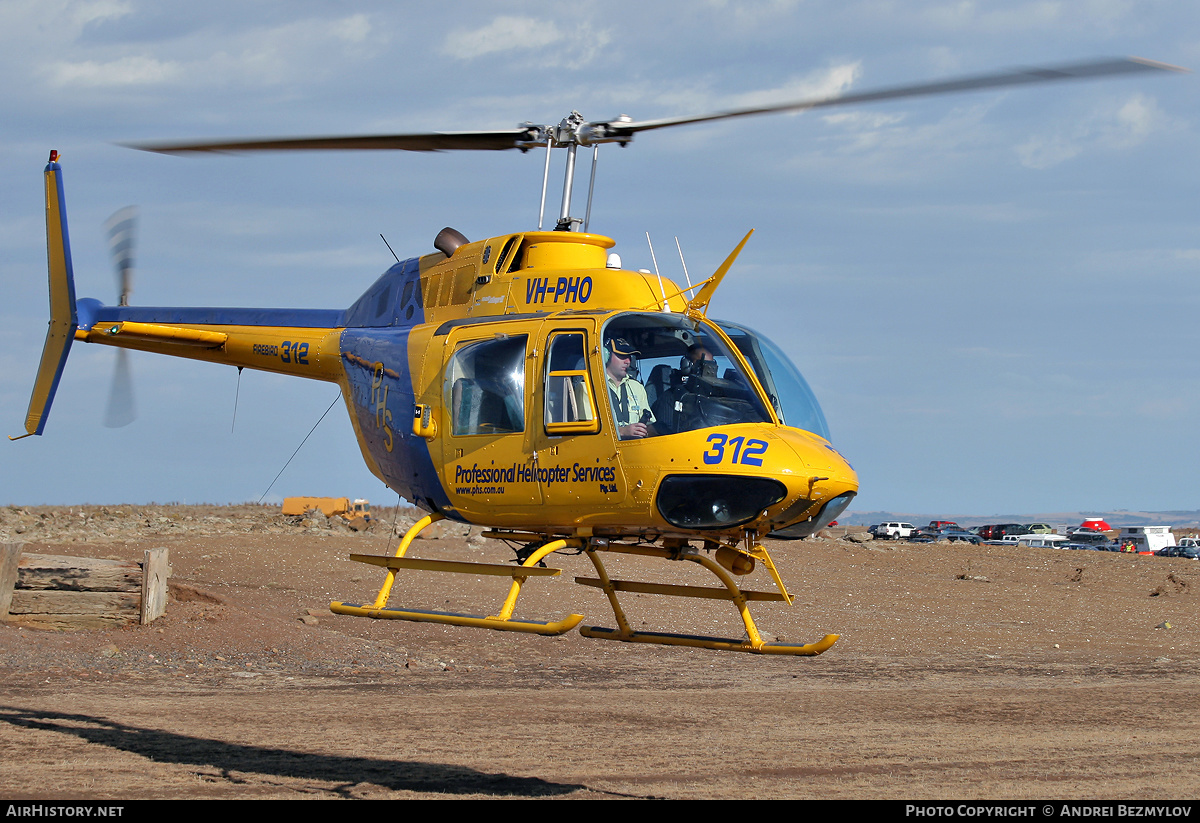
left=0, top=0, right=1200, bottom=515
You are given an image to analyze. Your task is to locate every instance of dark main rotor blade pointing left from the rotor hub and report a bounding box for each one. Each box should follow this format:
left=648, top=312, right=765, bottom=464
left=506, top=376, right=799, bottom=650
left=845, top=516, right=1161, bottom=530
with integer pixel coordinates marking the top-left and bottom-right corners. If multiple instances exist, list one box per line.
left=122, top=128, right=545, bottom=155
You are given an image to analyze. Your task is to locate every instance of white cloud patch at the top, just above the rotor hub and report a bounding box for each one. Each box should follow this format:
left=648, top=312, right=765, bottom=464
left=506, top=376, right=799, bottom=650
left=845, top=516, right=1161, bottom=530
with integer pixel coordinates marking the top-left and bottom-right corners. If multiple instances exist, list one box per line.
left=442, top=16, right=611, bottom=66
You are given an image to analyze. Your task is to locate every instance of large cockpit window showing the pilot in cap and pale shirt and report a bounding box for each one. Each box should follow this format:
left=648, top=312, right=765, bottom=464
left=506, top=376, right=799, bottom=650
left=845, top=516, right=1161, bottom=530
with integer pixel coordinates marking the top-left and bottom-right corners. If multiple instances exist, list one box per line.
left=602, top=313, right=770, bottom=439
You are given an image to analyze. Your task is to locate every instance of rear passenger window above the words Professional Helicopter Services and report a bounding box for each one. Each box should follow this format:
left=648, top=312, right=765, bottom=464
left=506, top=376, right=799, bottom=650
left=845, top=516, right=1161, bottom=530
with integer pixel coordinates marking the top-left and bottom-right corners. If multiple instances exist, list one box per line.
left=445, top=335, right=526, bottom=435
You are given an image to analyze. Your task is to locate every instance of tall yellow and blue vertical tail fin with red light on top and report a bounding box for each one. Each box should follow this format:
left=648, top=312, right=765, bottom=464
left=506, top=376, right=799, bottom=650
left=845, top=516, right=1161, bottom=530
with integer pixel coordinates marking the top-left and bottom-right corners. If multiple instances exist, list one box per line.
left=10, top=151, right=78, bottom=440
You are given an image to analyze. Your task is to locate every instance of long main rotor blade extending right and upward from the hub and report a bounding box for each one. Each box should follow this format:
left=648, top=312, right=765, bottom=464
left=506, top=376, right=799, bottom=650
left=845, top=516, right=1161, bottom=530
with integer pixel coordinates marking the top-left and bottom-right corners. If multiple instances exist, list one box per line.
left=605, top=58, right=1189, bottom=136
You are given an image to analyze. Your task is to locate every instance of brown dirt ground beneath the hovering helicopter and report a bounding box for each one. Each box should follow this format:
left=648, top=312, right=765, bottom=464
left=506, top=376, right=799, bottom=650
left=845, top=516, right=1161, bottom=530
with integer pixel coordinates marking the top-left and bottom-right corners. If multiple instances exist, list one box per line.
left=0, top=507, right=1200, bottom=799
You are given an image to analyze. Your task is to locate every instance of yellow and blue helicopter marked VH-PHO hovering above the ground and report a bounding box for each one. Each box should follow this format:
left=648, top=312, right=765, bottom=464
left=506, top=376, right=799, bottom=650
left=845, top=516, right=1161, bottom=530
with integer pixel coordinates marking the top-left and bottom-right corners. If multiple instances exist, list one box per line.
left=11, top=59, right=1172, bottom=655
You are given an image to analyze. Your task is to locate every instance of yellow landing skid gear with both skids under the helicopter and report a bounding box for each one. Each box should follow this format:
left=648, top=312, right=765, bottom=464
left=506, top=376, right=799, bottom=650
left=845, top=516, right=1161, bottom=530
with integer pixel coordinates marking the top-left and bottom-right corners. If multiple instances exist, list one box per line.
left=329, top=515, right=838, bottom=655
